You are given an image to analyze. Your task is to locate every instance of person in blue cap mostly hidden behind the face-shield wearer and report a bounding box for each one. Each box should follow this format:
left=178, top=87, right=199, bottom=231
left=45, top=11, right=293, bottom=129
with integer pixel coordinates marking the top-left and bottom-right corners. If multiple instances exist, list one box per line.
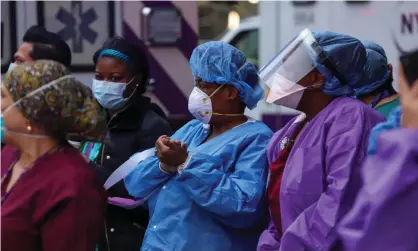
left=355, top=40, right=400, bottom=118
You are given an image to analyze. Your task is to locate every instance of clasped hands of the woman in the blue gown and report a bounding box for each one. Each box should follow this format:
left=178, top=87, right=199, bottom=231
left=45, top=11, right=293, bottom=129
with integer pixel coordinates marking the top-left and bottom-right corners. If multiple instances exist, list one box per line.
left=155, top=135, right=188, bottom=173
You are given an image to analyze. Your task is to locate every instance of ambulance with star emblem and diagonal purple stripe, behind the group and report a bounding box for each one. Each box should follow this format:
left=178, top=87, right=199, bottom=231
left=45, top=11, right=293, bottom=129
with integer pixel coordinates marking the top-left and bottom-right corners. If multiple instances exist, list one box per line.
left=1, top=1, right=198, bottom=129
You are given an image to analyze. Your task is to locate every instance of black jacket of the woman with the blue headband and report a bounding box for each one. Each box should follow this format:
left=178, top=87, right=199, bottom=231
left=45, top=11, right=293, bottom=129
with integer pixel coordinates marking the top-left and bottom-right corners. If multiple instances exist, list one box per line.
left=84, top=97, right=172, bottom=251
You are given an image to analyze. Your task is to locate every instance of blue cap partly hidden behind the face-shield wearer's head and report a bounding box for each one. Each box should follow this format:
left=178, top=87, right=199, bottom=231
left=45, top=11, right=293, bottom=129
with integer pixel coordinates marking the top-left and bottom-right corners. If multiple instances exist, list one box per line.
left=355, top=41, right=391, bottom=96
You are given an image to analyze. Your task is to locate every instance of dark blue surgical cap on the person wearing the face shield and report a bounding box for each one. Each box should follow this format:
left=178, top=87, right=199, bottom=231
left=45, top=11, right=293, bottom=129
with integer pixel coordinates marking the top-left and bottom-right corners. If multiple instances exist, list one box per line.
left=312, top=31, right=366, bottom=96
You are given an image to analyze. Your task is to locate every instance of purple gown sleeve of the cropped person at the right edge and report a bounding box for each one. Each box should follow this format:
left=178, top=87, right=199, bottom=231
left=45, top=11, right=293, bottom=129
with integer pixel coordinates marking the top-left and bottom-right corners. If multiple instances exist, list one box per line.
left=338, top=129, right=418, bottom=251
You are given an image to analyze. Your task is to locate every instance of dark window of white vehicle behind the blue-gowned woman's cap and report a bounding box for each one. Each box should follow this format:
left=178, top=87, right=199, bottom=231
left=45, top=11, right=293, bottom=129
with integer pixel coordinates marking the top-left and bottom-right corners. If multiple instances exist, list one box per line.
left=230, top=29, right=258, bottom=67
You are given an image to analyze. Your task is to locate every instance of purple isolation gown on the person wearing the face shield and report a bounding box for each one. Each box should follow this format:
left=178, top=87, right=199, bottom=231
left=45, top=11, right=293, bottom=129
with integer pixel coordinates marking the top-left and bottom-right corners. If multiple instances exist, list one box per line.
left=257, top=97, right=384, bottom=251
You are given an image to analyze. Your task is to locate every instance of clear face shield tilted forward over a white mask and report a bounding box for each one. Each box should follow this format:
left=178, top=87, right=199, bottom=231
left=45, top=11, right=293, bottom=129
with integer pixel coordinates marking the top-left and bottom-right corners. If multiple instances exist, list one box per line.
left=258, top=29, right=328, bottom=109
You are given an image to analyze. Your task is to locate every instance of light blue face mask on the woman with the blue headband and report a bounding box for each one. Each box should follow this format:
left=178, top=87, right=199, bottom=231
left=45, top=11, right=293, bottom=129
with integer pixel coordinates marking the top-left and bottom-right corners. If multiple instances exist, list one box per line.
left=92, top=77, right=138, bottom=110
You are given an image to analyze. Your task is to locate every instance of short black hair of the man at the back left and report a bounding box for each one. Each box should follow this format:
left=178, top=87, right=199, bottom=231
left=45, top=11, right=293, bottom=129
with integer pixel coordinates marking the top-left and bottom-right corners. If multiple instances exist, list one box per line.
left=23, top=25, right=71, bottom=67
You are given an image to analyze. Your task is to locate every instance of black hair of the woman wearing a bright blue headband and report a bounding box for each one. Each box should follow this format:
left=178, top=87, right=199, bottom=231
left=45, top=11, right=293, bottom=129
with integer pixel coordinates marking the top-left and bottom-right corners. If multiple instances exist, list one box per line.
left=93, top=37, right=149, bottom=95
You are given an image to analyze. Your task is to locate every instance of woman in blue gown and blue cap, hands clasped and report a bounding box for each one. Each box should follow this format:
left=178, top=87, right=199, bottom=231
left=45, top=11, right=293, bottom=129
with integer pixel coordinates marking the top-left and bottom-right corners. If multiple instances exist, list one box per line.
left=125, top=42, right=272, bottom=251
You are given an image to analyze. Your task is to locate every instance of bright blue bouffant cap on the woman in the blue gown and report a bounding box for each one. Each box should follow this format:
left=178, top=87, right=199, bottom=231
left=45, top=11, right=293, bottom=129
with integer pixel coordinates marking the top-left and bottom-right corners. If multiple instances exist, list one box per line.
left=190, top=41, right=264, bottom=109
